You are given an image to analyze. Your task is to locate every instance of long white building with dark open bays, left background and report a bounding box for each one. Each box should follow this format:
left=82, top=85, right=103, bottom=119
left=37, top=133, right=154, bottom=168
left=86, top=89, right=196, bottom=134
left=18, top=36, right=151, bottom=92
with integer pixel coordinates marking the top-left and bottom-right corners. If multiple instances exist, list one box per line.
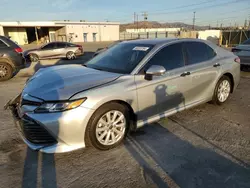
left=0, top=21, right=119, bottom=45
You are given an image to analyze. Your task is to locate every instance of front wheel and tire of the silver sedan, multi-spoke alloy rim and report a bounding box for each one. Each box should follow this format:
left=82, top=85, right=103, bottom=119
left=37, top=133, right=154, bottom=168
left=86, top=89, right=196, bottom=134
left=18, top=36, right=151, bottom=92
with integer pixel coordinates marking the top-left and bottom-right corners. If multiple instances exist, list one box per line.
left=85, top=103, right=130, bottom=150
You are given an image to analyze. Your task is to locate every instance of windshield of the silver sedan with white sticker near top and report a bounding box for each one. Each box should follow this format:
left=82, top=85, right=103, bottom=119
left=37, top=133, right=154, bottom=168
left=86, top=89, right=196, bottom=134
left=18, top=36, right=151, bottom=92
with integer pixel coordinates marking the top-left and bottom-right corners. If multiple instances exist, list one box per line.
left=85, top=42, right=154, bottom=74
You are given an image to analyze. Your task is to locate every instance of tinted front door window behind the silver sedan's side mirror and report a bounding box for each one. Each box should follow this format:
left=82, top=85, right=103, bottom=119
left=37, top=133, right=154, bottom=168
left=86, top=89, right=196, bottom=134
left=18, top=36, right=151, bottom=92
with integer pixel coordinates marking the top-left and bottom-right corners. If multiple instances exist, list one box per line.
left=144, top=43, right=184, bottom=70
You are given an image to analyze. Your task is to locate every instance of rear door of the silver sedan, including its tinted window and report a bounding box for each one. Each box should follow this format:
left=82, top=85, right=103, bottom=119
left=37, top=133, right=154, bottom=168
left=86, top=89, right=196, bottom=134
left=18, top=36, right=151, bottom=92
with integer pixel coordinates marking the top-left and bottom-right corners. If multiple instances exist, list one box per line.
left=184, top=41, right=221, bottom=104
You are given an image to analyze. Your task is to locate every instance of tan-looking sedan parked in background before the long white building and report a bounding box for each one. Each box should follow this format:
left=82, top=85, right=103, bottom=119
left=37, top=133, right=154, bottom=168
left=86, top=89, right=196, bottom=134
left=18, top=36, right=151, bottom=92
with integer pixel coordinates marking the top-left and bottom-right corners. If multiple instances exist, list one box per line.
left=24, top=42, right=83, bottom=62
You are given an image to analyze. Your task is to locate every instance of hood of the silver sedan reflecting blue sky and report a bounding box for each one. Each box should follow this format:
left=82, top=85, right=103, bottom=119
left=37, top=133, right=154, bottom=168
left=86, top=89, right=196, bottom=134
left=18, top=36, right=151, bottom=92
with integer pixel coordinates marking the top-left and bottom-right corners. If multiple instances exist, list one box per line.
left=23, top=65, right=121, bottom=101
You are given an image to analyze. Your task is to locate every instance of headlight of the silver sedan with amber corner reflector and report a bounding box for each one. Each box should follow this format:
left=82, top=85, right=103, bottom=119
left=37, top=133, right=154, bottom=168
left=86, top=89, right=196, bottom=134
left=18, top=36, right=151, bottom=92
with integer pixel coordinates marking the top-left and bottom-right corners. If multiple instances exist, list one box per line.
left=35, top=98, right=87, bottom=113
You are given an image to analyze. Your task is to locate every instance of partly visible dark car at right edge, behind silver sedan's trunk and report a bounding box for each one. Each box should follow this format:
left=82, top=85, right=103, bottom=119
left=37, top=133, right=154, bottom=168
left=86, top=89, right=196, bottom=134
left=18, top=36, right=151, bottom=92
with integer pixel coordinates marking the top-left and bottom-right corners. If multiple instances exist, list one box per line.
left=232, top=39, right=250, bottom=67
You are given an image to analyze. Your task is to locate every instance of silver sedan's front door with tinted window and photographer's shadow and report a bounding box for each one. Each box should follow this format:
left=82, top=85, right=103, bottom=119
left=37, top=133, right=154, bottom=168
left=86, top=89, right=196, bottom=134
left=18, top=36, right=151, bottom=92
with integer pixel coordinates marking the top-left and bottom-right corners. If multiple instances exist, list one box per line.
left=135, top=43, right=190, bottom=122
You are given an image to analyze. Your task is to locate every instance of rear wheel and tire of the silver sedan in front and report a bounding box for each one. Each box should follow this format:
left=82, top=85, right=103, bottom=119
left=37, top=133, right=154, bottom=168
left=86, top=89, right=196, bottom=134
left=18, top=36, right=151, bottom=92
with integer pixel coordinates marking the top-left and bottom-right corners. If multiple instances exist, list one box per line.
left=212, top=76, right=232, bottom=105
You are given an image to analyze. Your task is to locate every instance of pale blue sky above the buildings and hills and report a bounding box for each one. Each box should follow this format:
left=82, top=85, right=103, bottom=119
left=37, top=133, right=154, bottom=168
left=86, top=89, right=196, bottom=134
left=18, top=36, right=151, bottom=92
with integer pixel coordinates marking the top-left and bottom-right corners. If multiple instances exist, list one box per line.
left=0, top=0, right=250, bottom=26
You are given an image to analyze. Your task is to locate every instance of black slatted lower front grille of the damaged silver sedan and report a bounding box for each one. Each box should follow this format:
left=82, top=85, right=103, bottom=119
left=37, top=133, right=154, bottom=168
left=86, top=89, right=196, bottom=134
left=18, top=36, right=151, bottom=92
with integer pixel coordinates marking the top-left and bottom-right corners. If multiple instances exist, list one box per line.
left=20, top=116, right=56, bottom=145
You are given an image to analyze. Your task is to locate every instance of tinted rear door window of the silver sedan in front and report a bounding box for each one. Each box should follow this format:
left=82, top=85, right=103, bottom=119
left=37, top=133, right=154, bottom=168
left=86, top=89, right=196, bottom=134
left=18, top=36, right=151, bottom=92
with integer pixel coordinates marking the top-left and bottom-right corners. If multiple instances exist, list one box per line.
left=185, top=42, right=216, bottom=65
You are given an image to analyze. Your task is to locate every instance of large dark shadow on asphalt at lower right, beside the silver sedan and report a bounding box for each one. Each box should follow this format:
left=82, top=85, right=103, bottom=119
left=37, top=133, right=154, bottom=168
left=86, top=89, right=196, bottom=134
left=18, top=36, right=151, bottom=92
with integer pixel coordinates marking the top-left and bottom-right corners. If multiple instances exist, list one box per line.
left=125, top=123, right=250, bottom=188
